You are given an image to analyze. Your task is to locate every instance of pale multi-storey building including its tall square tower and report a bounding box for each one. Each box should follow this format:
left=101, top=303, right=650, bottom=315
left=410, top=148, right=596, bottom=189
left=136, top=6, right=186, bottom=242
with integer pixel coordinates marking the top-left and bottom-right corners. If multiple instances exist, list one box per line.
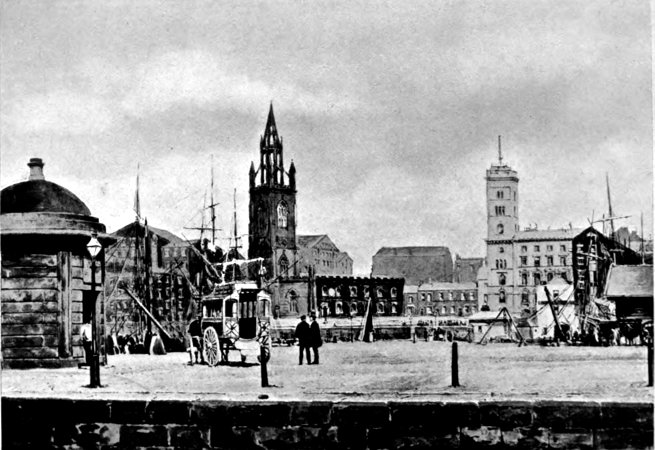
left=479, top=142, right=580, bottom=314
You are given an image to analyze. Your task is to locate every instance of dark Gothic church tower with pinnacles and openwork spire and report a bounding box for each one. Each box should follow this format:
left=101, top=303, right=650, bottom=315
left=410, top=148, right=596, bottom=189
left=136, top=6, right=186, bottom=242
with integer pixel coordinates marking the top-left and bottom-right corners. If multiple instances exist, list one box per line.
left=248, top=103, right=298, bottom=279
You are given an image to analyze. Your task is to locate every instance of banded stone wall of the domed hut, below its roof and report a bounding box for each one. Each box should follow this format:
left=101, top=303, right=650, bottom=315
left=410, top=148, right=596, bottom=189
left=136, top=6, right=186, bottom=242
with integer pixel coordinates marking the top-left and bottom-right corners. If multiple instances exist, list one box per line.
left=1, top=251, right=104, bottom=368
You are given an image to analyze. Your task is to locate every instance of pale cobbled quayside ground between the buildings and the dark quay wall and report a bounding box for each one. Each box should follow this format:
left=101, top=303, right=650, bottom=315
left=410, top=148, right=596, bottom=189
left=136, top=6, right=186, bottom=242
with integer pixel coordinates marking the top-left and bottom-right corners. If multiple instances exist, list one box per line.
left=2, top=341, right=652, bottom=401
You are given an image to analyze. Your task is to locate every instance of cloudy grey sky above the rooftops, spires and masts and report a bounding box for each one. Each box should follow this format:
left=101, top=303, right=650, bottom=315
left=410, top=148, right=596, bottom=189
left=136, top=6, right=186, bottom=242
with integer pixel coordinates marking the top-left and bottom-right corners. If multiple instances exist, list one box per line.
left=0, top=0, right=653, bottom=274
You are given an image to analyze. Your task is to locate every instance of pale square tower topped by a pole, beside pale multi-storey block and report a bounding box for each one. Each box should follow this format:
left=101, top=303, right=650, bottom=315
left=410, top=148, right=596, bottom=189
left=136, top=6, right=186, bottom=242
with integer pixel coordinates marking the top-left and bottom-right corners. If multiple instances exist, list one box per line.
left=484, top=136, right=519, bottom=310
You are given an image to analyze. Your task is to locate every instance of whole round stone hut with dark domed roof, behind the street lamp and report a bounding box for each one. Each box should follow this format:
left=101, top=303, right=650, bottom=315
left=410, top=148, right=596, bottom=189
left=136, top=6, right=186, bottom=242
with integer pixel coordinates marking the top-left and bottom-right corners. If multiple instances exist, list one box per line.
left=0, top=158, right=115, bottom=368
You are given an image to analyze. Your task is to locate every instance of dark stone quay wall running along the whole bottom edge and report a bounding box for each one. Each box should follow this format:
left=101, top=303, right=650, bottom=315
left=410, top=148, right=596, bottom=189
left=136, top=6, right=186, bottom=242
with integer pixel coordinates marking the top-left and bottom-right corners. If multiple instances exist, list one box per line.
left=2, top=398, right=653, bottom=449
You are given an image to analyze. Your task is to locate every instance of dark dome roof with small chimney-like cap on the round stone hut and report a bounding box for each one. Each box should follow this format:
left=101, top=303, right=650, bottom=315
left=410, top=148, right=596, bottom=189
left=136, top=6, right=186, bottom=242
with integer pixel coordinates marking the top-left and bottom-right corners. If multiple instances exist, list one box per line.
left=0, top=158, right=91, bottom=216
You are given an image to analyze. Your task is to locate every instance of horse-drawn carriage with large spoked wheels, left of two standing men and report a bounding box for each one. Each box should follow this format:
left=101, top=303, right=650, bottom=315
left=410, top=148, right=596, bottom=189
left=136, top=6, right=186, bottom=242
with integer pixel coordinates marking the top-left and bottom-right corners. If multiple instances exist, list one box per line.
left=200, top=282, right=271, bottom=366
